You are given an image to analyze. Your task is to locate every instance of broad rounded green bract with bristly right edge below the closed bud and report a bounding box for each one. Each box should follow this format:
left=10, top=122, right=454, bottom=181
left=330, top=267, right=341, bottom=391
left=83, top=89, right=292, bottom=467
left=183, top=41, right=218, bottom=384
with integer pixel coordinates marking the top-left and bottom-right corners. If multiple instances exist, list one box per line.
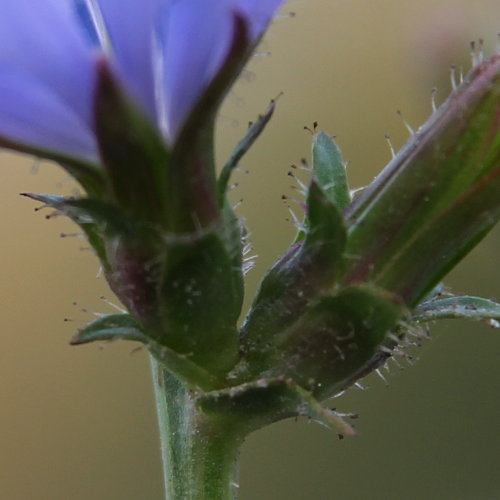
left=266, top=285, right=407, bottom=400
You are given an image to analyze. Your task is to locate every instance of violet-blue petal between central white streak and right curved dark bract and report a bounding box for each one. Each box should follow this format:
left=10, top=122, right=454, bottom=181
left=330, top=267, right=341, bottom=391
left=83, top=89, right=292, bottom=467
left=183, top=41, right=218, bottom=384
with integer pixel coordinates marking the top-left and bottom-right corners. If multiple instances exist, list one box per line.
left=155, top=0, right=234, bottom=141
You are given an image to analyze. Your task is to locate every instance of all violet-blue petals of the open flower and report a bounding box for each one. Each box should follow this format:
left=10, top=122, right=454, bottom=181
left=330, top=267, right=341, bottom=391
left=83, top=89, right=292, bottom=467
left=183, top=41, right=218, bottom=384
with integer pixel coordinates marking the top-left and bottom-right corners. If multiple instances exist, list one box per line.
left=0, top=0, right=283, bottom=164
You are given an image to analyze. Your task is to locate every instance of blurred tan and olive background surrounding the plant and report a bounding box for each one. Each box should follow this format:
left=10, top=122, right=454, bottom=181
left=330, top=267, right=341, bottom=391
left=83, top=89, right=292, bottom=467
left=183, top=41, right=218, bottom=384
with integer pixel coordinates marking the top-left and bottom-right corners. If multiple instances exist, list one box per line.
left=0, top=0, right=500, bottom=500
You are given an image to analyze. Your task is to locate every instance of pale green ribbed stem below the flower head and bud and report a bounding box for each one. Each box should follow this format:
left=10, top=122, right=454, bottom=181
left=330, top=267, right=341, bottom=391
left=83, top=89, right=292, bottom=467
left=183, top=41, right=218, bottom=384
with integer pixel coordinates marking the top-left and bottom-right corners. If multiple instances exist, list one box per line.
left=152, top=358, right=243, bottom=500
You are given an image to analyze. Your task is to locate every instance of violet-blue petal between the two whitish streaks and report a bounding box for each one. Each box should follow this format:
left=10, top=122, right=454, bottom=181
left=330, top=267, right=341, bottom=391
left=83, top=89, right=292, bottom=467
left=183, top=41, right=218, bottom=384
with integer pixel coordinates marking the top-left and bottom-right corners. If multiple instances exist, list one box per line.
left=93, top=0, right=166, bottom=117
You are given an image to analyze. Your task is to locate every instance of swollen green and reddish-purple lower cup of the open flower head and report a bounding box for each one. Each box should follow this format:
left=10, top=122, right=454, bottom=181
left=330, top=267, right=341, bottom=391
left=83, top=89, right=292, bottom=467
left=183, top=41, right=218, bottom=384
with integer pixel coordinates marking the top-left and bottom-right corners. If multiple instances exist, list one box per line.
left=99, top=228, right=242, bottom=376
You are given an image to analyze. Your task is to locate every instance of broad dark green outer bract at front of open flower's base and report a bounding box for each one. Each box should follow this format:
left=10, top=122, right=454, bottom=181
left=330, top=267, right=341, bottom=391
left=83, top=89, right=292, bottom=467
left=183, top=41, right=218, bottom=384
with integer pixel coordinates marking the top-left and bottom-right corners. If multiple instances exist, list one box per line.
left=157, top=233, right=242, bottom=373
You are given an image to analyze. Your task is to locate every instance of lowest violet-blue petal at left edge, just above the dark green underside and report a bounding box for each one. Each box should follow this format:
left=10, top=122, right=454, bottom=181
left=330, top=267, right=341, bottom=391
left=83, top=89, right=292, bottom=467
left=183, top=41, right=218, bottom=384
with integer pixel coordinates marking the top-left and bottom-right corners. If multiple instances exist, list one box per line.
left=0, top=67, right=98, bottom=164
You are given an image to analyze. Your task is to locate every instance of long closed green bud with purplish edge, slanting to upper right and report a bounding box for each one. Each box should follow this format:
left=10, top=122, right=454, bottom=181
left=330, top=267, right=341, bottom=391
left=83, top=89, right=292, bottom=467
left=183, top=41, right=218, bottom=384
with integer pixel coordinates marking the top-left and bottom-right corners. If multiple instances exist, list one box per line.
left=343, top=55, right=500, bottom=307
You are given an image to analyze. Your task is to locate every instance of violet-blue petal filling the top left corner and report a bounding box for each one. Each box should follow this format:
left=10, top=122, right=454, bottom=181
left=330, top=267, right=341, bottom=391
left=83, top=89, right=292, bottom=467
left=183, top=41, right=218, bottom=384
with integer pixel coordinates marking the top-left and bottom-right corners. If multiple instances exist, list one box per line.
left=0, top=0, right=95, bottom=129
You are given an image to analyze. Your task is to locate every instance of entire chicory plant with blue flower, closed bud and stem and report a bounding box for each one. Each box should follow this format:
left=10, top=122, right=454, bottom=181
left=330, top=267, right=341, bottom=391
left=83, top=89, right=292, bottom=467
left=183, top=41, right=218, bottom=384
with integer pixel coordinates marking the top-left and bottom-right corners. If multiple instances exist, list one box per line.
left=0, top=0, right=500, bottom=500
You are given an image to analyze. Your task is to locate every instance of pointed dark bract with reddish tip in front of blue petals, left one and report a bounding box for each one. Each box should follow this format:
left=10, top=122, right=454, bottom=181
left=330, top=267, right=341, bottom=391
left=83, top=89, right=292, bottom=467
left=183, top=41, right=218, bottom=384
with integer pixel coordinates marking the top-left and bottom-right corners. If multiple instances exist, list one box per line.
left=94, top=59, right=171, bottom=226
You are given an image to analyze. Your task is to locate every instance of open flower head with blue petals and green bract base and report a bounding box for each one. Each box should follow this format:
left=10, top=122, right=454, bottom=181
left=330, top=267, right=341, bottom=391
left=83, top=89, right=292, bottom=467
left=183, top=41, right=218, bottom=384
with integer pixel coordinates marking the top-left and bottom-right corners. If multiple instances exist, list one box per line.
left=0, top=0, right=283, bottom=372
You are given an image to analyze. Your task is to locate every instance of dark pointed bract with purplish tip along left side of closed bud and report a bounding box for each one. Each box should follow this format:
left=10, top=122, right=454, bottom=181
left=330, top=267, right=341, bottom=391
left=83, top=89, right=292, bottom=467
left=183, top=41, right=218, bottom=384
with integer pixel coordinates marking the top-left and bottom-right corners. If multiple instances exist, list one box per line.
left=242, top=179, right=346, bottom=372
